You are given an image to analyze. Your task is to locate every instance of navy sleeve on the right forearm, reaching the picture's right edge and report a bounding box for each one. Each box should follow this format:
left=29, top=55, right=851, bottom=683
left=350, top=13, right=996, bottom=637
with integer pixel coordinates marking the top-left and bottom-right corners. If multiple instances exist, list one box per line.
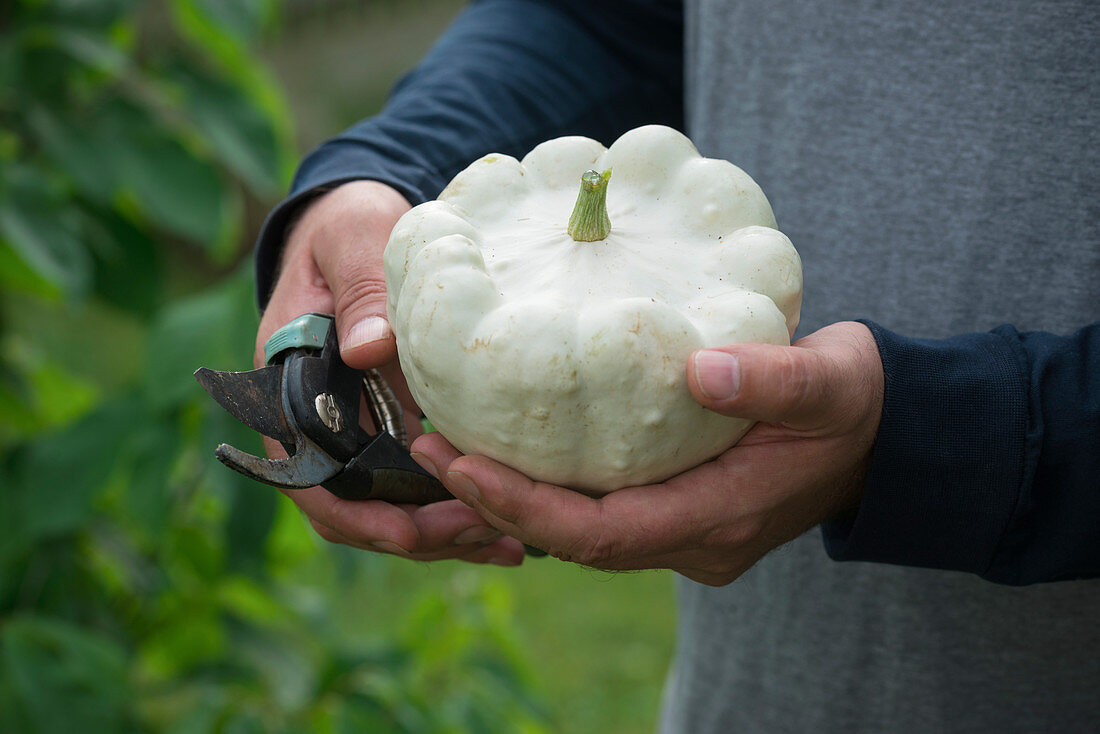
left=823, top=324, right=1100, bottom=584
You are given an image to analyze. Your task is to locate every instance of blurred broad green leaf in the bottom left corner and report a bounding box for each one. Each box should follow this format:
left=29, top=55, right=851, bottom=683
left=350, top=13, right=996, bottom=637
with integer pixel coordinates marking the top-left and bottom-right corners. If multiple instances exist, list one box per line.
left=0, top=616, right=130, bottom=734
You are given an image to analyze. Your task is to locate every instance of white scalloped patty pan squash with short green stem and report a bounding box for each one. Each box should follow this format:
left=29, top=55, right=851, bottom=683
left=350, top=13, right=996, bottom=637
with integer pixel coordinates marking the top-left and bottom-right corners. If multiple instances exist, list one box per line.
left=384, top=125, right=802, bottom=495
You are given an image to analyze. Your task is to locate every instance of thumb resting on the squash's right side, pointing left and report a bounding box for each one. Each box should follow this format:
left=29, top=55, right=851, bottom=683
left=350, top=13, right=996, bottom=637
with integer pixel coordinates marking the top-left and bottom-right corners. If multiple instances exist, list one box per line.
left=688, top=344, right=843, bottom=428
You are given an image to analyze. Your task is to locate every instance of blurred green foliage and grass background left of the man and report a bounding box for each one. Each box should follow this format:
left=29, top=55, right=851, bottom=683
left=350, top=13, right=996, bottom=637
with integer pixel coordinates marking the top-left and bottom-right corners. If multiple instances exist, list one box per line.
left=0, top=0, right=674, bottom=734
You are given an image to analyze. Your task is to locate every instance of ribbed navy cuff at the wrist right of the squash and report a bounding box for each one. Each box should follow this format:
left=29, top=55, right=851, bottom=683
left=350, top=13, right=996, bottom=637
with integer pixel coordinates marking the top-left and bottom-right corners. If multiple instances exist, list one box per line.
left=822, top=321, right=1027, bottom=577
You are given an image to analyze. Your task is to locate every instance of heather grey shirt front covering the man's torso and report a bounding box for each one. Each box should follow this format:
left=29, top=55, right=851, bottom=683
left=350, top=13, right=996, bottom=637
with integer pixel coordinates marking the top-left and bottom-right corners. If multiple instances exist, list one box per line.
left=661, top=0, right=1100, bottom=734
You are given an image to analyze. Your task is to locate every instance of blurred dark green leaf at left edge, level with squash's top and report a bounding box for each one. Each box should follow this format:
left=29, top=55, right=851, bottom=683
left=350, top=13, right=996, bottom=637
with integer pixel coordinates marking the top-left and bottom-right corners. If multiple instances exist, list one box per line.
left=0, top=165, right=91, bottom=299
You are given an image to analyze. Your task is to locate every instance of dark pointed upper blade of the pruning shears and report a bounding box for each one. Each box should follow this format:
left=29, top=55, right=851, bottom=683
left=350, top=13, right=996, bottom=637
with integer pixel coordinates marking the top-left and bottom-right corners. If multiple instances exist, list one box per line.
left=195, top=365, right=294, bottom=444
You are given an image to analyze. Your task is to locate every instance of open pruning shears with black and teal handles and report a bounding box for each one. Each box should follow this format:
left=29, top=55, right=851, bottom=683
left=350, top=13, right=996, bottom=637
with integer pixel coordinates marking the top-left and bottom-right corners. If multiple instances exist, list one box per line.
left=195, top=314, right=453, bottom=505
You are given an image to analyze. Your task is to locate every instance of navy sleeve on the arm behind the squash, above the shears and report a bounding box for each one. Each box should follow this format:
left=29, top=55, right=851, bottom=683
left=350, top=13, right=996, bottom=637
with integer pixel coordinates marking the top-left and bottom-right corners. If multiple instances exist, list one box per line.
left=256, top=0, right=683, bottom=307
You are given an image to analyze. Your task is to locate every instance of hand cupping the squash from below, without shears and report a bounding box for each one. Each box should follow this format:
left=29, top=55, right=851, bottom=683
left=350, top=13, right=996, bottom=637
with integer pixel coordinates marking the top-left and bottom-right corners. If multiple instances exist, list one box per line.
left=413, top=322, right=883, bottom=585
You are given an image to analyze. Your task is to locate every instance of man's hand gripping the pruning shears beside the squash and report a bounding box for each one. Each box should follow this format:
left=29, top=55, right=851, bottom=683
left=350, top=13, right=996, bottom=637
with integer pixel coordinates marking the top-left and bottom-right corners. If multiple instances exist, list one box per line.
left=254, top=182, right=524, bottom=566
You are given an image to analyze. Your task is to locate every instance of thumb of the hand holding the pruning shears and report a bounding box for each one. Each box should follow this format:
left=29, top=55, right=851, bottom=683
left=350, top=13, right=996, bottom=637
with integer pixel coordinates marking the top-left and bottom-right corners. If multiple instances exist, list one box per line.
left=310, top=182, right=409, bottom=369
